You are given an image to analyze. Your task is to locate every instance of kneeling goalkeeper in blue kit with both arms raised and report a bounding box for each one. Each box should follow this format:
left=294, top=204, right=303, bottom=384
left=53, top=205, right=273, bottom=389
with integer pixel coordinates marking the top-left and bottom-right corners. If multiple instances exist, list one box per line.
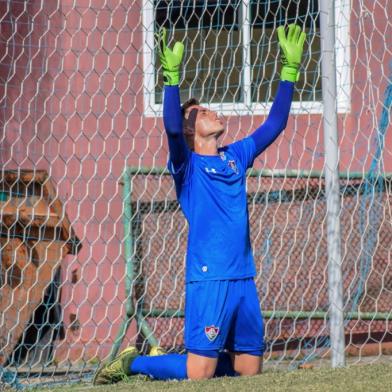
left=94, top=24, right=305, bottom=384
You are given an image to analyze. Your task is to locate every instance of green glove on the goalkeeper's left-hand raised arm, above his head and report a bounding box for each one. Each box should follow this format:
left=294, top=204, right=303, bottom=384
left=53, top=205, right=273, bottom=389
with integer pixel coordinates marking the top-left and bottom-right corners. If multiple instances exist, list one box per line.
left=155, top=27, right=184, bottom=86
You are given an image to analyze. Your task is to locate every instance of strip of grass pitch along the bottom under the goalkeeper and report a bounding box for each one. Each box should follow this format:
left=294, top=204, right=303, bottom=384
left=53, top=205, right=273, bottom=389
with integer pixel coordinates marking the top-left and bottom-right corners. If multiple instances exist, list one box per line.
left=26, top=364, right=392, bottom=392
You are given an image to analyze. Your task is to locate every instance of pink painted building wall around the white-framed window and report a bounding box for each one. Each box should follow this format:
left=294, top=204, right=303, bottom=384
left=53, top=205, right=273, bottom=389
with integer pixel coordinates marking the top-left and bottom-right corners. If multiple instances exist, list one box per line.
left=0, top=0, right=392, bottom=360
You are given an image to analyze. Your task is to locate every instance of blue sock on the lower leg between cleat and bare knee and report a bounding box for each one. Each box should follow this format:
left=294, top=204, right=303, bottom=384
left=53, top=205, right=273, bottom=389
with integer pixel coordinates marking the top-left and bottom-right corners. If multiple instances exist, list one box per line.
left=130, top=354, right=187, bottom=380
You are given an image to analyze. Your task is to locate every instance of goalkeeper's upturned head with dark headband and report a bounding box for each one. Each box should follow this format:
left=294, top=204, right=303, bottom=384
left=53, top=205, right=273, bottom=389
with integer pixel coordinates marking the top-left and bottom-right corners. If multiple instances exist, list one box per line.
left=185, top=105, right=225, bottom=139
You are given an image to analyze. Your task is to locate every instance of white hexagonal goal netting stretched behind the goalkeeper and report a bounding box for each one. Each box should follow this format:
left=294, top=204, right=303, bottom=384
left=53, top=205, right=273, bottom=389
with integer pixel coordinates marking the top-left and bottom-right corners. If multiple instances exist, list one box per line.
left=0, top=0, right=392, bottom=382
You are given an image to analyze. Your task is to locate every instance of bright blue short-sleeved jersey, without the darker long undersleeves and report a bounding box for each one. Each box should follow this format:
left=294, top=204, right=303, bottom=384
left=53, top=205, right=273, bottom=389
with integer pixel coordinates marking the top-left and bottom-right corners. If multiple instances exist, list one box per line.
left=168, top=137, right=257, bottom=282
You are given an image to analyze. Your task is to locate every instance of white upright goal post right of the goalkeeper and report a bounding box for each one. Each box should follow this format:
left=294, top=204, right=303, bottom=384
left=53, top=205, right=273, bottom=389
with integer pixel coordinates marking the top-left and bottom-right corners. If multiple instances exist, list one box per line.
left=319, top=1, right=345, bottom=367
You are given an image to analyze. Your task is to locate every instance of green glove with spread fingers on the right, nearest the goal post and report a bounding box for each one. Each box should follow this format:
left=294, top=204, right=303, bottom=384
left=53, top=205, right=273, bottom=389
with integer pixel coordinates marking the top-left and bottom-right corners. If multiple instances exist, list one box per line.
left=278, top=24, right=306, bottom=82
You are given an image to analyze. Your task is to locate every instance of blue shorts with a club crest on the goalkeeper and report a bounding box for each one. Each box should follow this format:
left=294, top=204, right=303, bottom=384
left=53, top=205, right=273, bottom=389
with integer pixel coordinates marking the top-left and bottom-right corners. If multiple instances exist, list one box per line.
left=185, top=278, right=265, bottom=357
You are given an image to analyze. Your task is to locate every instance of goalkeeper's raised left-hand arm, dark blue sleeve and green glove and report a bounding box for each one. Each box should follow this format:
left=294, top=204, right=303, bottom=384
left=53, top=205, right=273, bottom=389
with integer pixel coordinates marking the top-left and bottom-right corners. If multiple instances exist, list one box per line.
left=156, top=28, right=190, bottom=172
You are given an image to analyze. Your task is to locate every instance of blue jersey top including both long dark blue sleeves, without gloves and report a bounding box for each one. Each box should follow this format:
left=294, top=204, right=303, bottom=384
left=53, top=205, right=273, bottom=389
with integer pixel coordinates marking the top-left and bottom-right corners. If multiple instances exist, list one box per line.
left=163, top=81, right=294, bottom=282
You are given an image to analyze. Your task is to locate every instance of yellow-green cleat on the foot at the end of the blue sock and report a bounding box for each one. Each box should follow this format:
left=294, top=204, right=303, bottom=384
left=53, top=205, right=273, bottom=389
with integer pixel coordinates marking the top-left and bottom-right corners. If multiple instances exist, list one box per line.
left=93, top=346, right=139, bottom=385
